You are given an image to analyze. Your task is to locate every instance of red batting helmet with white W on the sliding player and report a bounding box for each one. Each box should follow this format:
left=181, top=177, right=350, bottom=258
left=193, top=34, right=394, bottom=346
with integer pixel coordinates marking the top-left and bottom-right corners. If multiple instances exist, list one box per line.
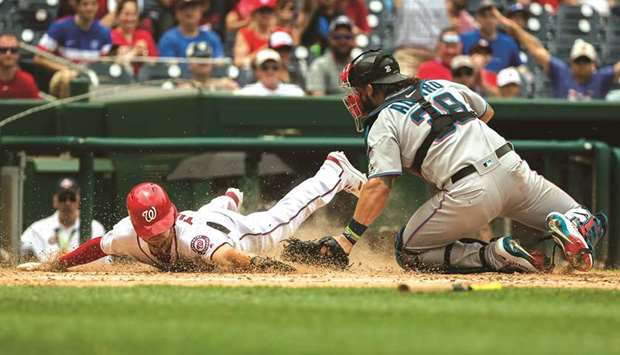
left=127, top=182, right=177, bottom=240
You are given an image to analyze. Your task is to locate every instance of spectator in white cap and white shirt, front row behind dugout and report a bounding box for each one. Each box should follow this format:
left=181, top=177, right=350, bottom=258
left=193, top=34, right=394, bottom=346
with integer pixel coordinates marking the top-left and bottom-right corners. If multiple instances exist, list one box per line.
left=237, top=49, right=304, bottom=96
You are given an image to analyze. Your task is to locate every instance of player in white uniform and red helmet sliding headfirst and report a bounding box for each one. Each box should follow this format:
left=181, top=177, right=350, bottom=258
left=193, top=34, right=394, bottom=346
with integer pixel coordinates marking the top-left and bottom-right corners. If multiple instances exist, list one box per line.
left=21, top=152, right=366, bottom=272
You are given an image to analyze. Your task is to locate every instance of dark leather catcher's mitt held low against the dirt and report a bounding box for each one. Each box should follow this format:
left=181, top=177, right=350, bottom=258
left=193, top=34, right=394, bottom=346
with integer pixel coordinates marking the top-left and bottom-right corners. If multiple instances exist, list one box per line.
left=282, top=236, right=349, bottom=269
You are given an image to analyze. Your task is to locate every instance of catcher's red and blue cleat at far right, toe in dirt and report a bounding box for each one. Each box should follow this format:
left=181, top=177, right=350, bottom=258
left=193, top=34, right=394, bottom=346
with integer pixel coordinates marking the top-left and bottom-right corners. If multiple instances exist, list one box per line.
left=546, top=212, right=594, bottom=271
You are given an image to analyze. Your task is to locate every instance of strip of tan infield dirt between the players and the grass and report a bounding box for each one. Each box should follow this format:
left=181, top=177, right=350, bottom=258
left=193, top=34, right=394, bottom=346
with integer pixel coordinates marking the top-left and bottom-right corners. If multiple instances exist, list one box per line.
left=0, top=265, right=620, bottom=289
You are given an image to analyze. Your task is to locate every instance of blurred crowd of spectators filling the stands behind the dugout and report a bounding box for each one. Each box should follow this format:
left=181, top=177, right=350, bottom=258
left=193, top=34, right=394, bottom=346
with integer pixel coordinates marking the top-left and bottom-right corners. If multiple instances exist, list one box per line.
left=0, top=0, right=620, bottom=100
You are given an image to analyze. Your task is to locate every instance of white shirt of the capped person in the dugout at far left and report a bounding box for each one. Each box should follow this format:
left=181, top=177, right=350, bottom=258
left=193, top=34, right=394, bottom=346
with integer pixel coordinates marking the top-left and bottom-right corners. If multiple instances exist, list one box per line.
left=21, top=211, right=105, bottom=262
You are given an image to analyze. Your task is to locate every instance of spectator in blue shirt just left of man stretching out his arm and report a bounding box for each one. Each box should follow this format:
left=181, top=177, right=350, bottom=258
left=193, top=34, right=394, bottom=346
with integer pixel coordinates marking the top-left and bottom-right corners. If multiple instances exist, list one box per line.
left=461, top=0, right=521, bottom=73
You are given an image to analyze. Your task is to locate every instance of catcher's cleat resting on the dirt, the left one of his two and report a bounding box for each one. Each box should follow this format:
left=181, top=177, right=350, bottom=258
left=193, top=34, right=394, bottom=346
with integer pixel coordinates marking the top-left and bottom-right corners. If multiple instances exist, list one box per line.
left=493, top=236, right=540, bottom=272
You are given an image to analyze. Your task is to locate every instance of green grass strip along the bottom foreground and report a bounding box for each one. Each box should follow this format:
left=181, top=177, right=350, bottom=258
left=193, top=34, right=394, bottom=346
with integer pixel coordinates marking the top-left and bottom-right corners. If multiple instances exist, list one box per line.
left=0, top=286, right=620, bottom=355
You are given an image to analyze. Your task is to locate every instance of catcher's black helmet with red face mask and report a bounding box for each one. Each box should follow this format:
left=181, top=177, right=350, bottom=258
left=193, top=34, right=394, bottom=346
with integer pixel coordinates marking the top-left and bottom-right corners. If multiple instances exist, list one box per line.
left=340, top=49, right=407, bottom=132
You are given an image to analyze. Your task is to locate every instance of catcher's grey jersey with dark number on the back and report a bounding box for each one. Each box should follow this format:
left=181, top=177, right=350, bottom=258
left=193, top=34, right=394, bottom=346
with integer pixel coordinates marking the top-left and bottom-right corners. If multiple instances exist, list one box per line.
left=367, top=80, right=506, bottom=188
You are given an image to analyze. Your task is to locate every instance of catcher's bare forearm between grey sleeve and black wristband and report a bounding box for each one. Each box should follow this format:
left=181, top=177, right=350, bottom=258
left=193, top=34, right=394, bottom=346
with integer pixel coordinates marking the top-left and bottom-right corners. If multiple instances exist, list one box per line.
left=353, top=178, right=391, bottom=226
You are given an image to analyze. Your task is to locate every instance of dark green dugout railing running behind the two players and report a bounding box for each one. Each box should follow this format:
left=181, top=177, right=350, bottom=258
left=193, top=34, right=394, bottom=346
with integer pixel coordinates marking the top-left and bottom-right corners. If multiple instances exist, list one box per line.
left=0, top=136, right=620, bottom=266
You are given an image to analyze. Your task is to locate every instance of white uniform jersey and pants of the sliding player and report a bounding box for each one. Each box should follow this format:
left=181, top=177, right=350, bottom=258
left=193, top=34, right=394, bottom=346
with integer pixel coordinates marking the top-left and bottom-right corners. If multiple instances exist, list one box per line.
left=100, top=161, right=345, bottom=269
